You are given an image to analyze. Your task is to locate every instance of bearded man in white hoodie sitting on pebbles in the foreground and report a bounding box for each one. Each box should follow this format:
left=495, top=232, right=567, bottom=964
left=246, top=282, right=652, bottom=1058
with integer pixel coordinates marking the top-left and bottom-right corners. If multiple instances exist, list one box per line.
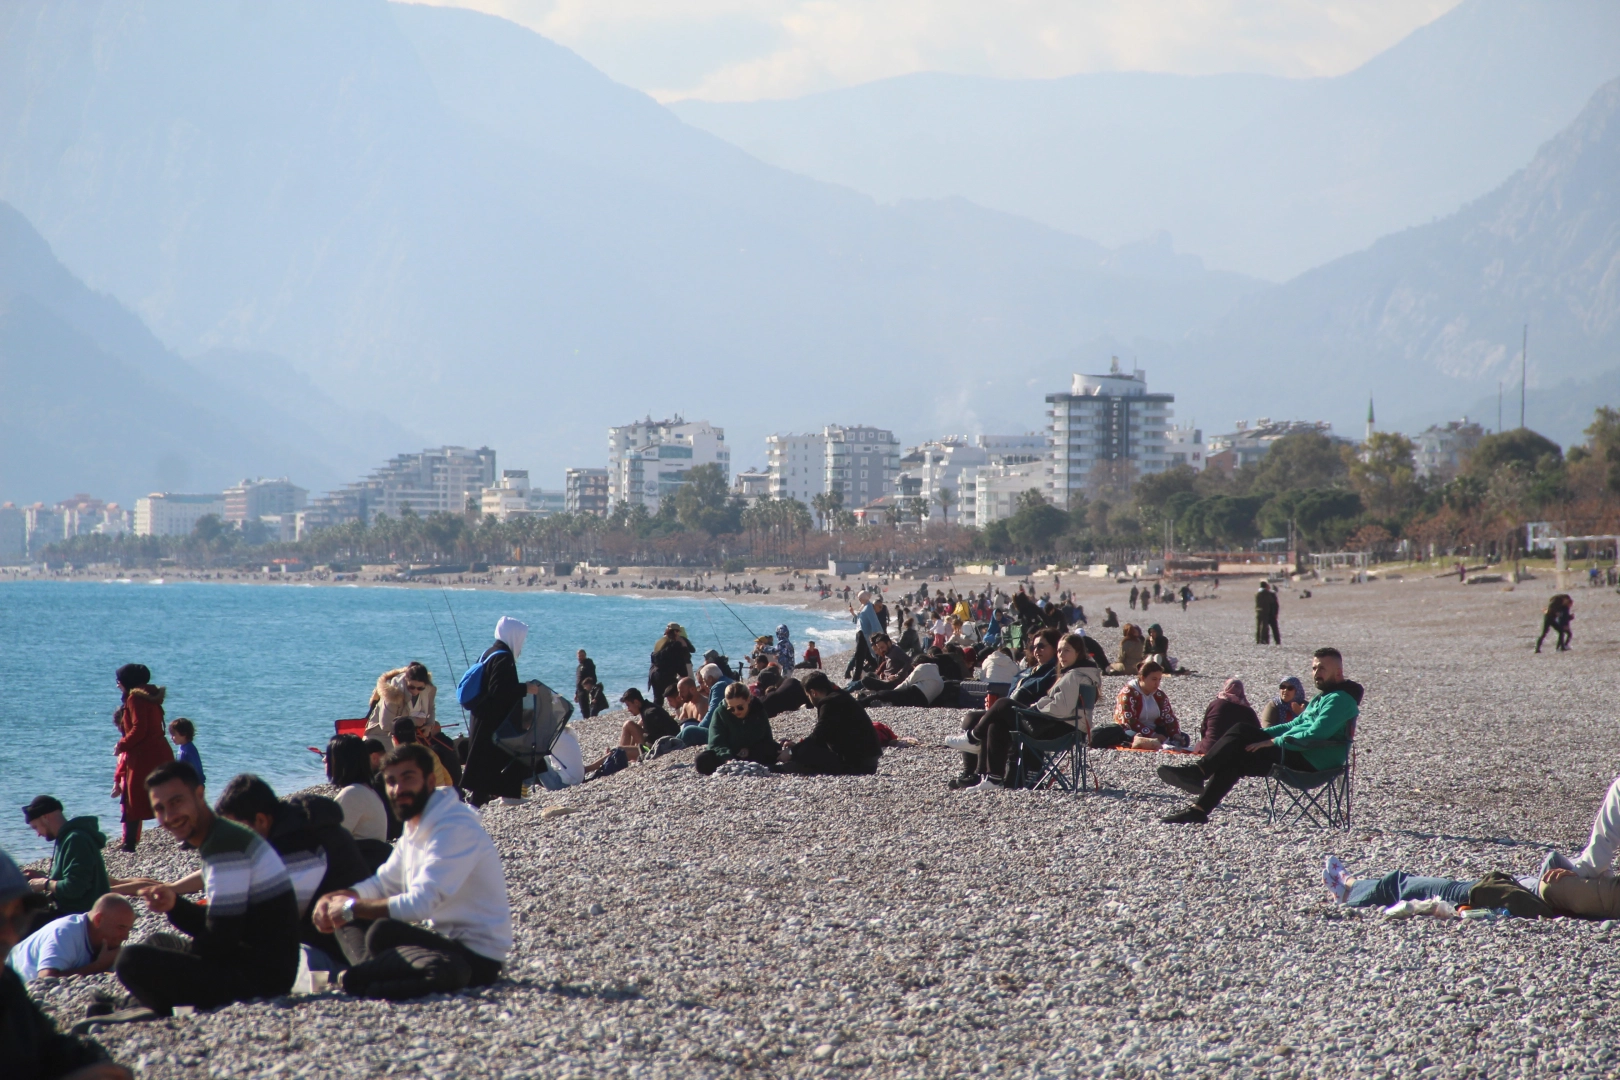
left=313, top=743, right=512, bottom=999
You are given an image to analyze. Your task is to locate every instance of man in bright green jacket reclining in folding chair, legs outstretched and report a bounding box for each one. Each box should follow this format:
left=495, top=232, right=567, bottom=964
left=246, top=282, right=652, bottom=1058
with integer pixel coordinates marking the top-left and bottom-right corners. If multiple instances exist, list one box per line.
left=1158, top=649, right=1362, bottom=824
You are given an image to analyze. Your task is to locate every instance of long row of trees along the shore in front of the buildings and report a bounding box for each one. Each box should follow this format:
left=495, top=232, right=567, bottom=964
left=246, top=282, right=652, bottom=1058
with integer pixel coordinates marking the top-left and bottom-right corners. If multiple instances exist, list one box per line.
left=47, top=408, right=1620, bottom=567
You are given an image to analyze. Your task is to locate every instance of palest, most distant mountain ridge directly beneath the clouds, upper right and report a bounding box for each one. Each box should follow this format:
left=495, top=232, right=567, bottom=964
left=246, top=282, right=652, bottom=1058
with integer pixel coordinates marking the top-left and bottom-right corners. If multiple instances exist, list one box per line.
left=672, top=0, right=1620, bottom=280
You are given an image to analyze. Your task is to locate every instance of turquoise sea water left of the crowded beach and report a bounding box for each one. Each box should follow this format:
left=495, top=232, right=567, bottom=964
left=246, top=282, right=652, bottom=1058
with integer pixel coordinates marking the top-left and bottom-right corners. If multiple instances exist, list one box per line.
left=0, top=581, right=852, bottom=860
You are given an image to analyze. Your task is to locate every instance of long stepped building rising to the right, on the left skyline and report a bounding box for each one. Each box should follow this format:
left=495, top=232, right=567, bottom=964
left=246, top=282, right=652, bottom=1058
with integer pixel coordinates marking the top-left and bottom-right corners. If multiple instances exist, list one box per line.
left=305, top=447, right=496, bottom=531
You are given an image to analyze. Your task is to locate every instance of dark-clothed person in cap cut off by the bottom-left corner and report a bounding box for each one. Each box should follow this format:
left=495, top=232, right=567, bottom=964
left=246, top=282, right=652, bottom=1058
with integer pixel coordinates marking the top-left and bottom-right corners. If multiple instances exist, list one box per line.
left=0, top=852, right=130, bottom=1080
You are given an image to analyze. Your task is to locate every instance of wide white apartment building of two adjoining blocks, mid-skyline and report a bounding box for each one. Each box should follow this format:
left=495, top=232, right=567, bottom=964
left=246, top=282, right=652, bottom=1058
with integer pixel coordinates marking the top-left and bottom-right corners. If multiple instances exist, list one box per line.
left=765, top=424, right=901, bottom=510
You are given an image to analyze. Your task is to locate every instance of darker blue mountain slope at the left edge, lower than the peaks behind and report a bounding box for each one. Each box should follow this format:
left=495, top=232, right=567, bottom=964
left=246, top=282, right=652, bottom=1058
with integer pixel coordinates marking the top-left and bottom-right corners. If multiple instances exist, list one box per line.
left=0, top=202, right=421, bottom=505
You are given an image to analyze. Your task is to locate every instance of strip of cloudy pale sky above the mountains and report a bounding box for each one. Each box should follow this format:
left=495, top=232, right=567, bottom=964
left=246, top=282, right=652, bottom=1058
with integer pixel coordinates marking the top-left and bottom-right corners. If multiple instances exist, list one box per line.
left=411, top=0, right=1458, bottom=100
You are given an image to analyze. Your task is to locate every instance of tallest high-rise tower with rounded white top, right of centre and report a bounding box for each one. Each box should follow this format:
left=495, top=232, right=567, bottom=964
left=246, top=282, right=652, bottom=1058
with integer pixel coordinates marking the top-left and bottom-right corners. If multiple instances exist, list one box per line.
left=1047, top=356, right=1176, bottom=507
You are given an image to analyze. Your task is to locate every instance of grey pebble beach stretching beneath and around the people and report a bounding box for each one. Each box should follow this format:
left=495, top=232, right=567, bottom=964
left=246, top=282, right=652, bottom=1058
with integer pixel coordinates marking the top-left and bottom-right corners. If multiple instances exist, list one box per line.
left=22, top=576, right=1620, bottom=1078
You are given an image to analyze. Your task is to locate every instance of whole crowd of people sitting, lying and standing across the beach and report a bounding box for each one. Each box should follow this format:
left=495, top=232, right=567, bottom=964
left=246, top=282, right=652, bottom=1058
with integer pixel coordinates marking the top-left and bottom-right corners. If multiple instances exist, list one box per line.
left=0, top=569, right=1620, bottom=1077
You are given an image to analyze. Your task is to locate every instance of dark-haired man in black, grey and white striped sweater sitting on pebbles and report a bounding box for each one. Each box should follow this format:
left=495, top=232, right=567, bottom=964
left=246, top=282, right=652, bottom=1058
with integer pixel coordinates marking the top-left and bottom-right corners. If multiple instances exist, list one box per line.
left=113, top=761, right=298, bottom=1015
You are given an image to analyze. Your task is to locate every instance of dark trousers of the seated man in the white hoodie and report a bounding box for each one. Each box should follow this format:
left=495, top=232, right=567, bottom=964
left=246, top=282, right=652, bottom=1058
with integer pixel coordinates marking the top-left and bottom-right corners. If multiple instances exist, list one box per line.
left=339, top=918, right=501, bottom=1001
